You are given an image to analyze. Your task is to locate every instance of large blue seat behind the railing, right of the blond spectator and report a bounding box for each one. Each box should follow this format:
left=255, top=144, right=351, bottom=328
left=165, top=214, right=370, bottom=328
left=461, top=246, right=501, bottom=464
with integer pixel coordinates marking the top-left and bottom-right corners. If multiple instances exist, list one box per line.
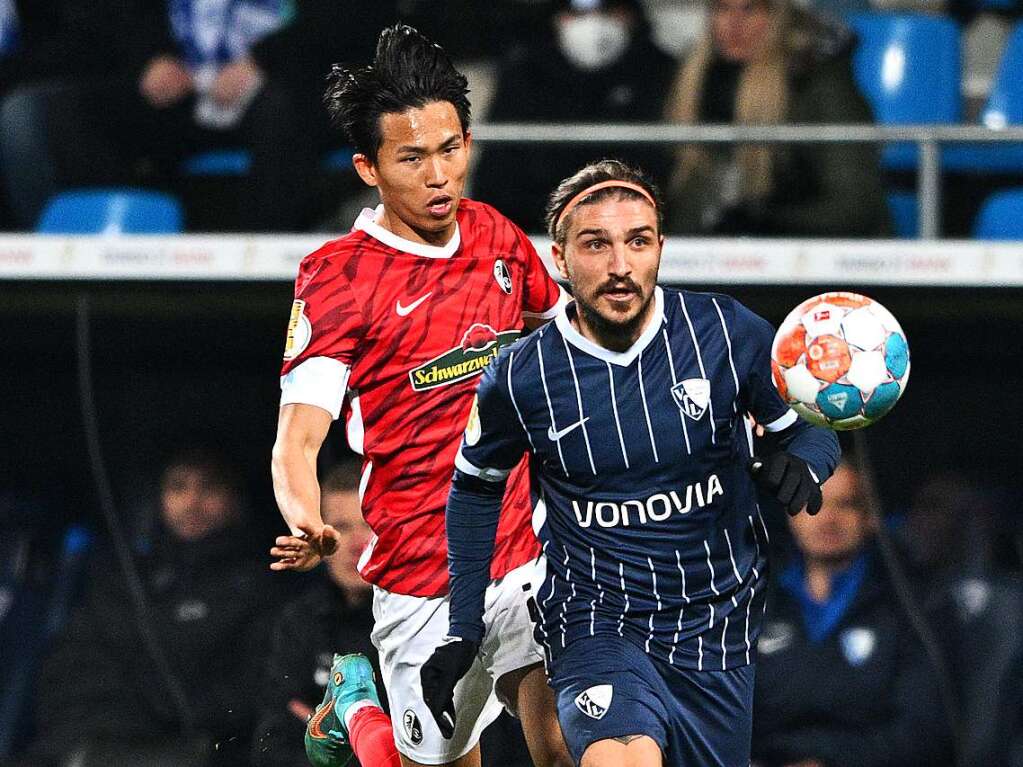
left=848, top=13, right=962, bottom=170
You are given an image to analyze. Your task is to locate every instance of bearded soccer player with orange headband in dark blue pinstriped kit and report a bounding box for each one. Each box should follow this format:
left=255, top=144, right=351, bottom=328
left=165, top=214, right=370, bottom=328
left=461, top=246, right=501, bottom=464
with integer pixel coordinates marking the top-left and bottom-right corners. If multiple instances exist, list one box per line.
left=421, top=161, right=839, bottom=767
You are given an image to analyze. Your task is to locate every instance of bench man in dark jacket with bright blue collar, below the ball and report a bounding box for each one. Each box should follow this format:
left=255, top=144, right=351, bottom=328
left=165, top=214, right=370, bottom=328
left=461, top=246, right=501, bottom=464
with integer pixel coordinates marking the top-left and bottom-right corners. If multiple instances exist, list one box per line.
left=753, top=462, right=949, bottom=767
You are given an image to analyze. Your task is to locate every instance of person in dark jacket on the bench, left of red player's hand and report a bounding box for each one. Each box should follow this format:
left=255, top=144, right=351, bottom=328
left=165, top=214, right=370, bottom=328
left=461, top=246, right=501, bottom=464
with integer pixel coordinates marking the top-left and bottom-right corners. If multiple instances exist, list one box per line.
left=20, top=450, right=278, bottom=767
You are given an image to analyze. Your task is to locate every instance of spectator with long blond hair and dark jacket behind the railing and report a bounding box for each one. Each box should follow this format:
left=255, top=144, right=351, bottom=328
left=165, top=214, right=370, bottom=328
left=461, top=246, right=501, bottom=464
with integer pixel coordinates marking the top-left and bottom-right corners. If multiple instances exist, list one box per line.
left=667, top=0, right=889, bottom=237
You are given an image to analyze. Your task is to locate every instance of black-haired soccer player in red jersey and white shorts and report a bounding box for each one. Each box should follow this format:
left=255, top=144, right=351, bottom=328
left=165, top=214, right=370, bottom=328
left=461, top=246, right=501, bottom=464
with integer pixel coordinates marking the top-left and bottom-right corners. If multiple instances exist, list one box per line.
left=271, top=25, right=571, bottom=767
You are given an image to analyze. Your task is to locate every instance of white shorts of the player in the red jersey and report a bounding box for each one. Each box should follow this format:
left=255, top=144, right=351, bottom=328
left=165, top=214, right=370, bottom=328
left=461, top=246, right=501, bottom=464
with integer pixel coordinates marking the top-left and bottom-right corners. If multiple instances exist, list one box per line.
left=372, top=561, right=543, bottom=764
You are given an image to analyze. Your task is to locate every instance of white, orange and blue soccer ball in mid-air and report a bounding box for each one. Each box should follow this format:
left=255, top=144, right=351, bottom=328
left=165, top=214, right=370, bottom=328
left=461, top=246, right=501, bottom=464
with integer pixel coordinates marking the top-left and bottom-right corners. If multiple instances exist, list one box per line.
left=770, top=292, right=909, bottom=431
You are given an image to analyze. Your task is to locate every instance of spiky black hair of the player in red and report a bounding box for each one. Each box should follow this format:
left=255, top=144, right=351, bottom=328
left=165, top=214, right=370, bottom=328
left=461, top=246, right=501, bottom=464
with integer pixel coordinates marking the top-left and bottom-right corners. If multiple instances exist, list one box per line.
left=323, top=24, right=472, bottom=162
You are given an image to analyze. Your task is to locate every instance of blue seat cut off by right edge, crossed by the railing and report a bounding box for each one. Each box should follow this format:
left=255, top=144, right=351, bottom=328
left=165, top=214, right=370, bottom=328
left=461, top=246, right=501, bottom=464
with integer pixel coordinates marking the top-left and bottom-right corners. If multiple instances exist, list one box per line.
left=943, top=21, right=1023, bottom=173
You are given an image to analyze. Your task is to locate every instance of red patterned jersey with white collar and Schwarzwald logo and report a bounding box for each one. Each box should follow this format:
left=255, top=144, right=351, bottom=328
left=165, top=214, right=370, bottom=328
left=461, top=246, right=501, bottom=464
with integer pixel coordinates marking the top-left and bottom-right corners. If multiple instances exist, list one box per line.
left=281, top=199, right=561, bottom=596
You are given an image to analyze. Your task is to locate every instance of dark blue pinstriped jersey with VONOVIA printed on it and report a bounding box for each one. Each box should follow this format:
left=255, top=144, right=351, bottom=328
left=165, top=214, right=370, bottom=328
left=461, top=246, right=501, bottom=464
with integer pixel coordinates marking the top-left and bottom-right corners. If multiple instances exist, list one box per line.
left=456, top=288, right=796, bottom=669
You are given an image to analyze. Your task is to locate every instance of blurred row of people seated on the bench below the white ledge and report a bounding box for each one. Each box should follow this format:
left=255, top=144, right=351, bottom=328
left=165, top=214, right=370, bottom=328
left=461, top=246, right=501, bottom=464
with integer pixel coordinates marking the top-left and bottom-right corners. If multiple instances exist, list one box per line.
left=0, top=433, right=1023, bottom=767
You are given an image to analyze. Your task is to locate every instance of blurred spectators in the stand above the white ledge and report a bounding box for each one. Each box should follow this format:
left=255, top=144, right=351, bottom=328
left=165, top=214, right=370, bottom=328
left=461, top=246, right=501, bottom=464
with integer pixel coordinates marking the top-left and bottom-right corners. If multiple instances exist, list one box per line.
left=0, top=0, right=1017, bottom=237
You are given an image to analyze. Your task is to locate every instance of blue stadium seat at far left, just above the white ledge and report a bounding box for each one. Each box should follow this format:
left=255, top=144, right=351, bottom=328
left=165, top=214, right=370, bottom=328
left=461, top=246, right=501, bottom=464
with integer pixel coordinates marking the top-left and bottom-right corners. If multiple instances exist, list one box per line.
left=36, top=188, right=184, bottom=234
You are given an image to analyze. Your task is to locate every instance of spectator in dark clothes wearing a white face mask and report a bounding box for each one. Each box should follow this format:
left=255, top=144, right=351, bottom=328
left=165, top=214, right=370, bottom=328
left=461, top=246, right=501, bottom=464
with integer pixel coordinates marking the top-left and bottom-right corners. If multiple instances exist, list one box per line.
left=473, top=0, right=675, bottom=231
